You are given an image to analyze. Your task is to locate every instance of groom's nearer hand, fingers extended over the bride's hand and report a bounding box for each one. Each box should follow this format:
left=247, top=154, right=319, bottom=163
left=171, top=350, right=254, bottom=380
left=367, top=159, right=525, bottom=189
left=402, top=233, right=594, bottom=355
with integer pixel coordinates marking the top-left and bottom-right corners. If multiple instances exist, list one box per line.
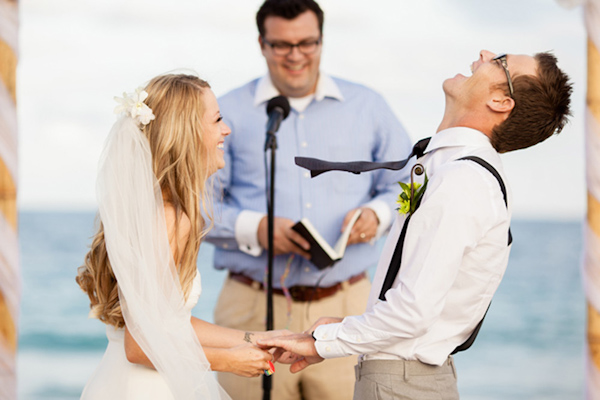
left=257, top=333, right=323, bottom=373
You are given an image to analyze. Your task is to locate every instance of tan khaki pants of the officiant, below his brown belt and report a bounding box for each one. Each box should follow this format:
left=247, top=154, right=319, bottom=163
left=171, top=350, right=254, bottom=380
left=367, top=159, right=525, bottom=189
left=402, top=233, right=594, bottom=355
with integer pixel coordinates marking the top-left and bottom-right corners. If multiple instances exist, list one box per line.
left=215, top=278, right=371, bottom=400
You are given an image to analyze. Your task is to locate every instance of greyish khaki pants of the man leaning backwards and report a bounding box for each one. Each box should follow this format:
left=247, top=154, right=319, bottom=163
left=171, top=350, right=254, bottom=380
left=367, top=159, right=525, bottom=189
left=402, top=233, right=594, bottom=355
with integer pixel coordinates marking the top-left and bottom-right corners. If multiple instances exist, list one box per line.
left=354, top=357, right=459, bottom=400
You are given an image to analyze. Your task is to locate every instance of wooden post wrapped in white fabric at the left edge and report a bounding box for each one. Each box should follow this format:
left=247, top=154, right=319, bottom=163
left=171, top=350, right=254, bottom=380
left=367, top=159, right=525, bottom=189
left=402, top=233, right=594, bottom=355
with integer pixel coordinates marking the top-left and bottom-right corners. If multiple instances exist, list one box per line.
left=0, top=0, right=20, bottom=399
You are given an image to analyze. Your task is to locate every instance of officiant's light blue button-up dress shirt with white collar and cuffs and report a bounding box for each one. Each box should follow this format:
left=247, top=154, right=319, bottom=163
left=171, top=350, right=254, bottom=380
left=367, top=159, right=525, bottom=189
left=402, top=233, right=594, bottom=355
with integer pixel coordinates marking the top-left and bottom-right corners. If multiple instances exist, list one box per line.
left=207, top=73, right=411, bottom=288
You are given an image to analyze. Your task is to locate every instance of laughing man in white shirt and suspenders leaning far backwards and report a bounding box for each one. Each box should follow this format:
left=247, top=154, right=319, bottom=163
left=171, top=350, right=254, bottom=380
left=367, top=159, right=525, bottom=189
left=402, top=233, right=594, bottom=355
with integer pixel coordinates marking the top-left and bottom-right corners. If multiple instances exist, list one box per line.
left=259, top=50, right=572, bottom=400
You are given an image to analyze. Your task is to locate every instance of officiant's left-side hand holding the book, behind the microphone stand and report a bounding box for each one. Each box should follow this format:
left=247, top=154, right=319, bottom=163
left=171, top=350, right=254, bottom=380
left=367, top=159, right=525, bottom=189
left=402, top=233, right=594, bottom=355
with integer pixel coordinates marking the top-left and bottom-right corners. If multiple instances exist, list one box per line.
left=257, top=216, right=310, bottom=259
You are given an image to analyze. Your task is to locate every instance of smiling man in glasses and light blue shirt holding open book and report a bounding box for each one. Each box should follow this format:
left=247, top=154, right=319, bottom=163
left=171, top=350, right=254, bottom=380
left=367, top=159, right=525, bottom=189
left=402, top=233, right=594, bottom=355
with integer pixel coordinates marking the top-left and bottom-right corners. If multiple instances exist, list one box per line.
left=207, top=0, right=410, bottom=400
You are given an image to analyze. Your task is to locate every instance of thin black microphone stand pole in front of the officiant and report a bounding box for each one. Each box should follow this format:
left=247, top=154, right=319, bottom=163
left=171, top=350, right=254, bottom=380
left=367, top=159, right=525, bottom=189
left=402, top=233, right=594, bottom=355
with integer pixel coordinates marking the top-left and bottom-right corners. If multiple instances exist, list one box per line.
left=262, top=132, right=277, bottom=400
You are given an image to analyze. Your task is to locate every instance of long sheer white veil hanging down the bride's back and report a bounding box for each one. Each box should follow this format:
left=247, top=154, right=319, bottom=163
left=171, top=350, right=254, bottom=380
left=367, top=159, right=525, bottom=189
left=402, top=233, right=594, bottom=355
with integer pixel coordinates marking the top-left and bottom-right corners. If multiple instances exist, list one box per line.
left=96, top=115, right=229, bottom=399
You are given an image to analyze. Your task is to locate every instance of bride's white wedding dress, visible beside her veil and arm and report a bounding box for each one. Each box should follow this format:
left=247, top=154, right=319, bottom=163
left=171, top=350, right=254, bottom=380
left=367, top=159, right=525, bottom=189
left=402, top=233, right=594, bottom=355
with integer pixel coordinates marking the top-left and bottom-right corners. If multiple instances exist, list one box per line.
left=81, top=271, right=202, bottom=400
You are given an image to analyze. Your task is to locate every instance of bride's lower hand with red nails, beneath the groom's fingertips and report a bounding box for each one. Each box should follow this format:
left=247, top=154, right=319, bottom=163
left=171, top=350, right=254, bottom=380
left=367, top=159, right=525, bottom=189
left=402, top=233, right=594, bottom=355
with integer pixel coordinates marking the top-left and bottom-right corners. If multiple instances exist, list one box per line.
left=224, top=343, right=273, bottom=378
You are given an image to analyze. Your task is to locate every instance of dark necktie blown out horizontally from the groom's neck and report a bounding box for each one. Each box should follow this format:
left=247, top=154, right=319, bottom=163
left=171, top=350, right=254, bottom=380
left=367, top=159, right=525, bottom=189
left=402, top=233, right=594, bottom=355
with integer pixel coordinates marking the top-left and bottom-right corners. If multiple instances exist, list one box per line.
left=294, top=138, right=431, bottom=178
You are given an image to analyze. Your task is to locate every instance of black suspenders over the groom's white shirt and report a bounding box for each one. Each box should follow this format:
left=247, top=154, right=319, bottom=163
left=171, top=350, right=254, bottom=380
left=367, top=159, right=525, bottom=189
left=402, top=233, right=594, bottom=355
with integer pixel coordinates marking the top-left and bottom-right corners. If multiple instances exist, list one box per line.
left=379, top=156, right=512, bottom=354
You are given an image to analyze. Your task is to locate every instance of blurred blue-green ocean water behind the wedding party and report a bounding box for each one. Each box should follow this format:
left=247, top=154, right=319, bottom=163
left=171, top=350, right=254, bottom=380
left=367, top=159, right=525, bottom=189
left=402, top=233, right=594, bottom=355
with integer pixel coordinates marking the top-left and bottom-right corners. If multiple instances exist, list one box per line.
left=17, top=212, right=585, bottom=400
